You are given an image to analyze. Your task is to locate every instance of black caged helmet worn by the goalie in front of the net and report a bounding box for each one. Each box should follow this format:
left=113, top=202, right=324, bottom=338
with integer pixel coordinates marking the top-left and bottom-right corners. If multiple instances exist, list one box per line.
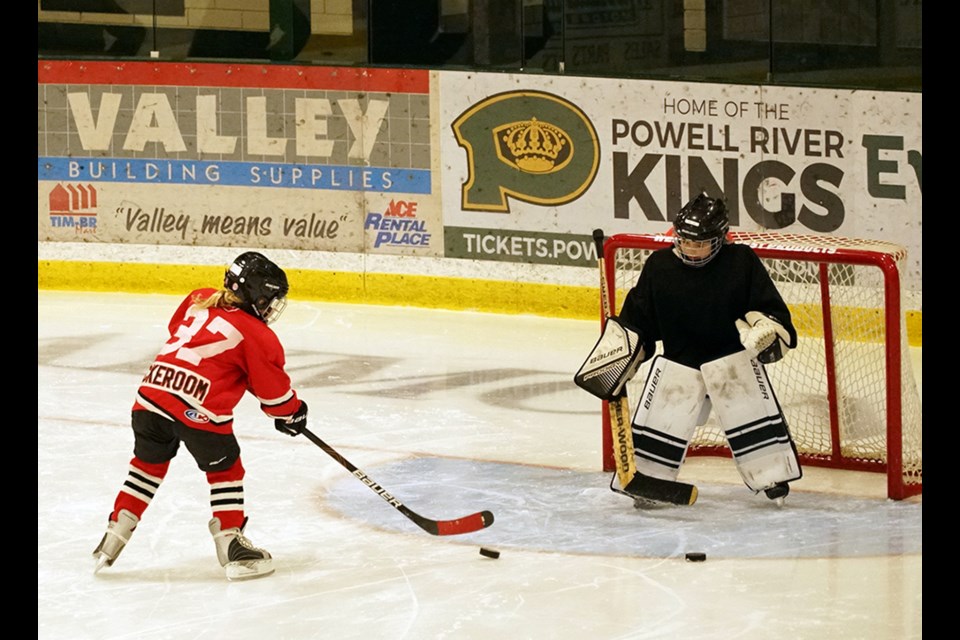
left=673, top=193, right=730, bottom=267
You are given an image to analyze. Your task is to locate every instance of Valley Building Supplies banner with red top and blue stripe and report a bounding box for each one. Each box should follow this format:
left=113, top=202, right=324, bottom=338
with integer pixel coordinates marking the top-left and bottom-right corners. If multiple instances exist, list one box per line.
left=37, top=61, right=443, bottom=256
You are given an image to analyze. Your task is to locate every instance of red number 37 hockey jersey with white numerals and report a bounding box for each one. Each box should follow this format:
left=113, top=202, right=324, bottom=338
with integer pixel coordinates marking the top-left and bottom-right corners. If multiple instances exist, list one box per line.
left=133, top=289, right=300, bottom=433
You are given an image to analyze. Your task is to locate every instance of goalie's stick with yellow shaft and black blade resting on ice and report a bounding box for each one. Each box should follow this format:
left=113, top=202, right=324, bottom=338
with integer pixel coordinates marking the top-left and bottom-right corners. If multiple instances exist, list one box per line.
left=593, top=229, right=697, bottom=505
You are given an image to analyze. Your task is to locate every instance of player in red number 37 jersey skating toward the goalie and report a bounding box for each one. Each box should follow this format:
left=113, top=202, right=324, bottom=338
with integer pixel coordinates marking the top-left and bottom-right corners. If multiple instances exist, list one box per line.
left=93, top=251, right=307, bottom=580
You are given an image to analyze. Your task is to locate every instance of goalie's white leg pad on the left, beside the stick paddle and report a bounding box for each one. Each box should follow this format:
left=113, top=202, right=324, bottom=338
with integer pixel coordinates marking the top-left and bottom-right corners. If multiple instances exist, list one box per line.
left=633, top=356, right=706, bottom=480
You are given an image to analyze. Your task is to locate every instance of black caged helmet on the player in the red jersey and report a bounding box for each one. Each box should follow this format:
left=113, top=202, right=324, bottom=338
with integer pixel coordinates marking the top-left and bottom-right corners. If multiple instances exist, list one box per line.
left=223, top=251, right=290, bottom=324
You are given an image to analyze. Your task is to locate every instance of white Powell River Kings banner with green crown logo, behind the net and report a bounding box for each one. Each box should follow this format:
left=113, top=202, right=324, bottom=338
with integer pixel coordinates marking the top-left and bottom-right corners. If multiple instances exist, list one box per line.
left=439, top=72, right=923, bottom=291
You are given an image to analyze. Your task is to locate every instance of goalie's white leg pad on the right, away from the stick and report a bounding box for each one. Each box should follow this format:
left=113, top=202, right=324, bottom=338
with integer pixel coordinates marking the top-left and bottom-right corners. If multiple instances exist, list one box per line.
left=700, top=351, right=802, bottom=492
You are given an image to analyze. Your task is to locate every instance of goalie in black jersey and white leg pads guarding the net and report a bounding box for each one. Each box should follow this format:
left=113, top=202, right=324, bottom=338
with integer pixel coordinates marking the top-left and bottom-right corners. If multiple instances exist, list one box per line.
left=584, top=194, right=802, bottom=504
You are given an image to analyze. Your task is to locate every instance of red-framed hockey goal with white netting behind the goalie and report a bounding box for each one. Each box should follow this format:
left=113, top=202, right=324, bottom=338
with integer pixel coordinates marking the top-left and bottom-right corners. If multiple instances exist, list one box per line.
left=601, top=232, right=923, bottom=500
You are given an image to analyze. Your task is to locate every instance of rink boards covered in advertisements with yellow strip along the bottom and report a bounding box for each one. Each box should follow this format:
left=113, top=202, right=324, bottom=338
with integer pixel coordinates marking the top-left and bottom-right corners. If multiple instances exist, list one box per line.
left=37, top=60, right=922, bottom=344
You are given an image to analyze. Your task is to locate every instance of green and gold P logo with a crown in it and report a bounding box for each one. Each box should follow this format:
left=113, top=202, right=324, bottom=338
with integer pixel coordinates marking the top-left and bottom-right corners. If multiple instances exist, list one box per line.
left=452, top=91, right=600, bottom=212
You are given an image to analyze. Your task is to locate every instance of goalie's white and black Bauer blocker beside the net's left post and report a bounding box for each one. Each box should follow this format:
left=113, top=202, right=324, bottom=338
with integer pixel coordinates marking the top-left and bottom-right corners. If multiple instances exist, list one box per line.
left=573, top=316, right=646, bottom=400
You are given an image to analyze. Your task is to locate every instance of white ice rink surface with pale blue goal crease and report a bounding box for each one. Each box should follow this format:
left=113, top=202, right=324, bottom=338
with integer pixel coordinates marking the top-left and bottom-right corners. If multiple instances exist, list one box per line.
left=37, top=291, right=923, bottom=640
